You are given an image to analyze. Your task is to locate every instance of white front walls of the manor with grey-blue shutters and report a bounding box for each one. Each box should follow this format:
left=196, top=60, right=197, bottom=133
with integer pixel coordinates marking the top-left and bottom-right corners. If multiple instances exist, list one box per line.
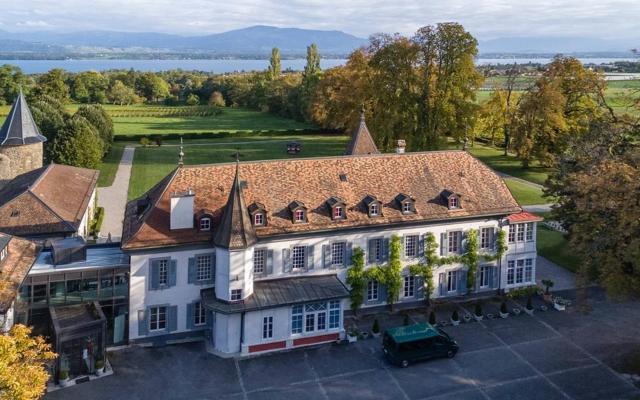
left=129, top=214, right=536, bottom=353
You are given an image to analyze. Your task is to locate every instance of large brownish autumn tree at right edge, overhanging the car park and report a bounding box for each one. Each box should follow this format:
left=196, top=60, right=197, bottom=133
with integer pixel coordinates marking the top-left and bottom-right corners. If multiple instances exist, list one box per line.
left=546, top=120, right=640, bottom=298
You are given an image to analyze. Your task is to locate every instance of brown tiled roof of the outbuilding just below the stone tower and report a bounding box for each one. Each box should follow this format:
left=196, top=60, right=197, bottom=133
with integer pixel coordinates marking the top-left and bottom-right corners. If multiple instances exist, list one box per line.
left=0, top=164, right=99, bottom=236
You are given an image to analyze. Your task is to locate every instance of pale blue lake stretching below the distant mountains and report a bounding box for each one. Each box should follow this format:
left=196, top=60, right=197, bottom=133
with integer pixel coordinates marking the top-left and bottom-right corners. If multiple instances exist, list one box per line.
left=0, top=57, right=640, bottom=74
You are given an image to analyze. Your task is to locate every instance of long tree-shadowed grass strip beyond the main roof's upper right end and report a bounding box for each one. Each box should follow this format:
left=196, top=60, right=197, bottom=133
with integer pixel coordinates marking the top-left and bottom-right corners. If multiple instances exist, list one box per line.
left=469, top=143, right=553, bottom=187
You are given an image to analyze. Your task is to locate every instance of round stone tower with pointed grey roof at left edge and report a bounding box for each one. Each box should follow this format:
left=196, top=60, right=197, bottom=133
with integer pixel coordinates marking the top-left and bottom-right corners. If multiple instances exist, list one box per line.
left=0, top=91, right=47, bottom=188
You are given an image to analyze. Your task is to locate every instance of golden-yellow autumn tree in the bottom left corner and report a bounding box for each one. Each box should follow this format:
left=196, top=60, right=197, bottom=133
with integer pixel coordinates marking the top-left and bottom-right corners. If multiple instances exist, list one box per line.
left=0, top=325, right=56, bottom=400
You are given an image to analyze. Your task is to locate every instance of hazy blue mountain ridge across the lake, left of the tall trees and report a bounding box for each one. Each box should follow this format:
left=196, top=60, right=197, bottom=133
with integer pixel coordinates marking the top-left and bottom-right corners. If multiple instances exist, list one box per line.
left=0, top=26, right=367, bottom=55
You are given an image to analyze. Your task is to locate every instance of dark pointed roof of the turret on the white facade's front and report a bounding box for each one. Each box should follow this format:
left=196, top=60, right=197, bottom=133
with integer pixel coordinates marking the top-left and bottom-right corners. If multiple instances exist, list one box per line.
left=213, top=163, right=256, bottom=250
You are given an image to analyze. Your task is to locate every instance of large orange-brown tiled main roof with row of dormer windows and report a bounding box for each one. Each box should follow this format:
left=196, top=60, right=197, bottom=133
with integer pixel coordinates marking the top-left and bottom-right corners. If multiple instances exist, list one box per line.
left=122, top=151, right=522, bottom=249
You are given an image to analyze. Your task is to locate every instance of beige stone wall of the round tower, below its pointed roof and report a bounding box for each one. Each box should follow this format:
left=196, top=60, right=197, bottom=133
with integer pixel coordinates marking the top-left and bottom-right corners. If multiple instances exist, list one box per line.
left=0, top=143, right=42, bottom=188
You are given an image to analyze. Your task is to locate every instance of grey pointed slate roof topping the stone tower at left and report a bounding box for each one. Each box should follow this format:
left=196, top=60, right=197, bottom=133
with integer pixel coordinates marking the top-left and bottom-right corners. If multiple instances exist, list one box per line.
left=0, top=91, right=47, bottom=146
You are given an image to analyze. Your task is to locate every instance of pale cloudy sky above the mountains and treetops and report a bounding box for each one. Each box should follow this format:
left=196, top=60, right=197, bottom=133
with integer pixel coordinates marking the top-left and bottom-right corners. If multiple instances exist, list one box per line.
left=0, top=0, right=640, bottom=40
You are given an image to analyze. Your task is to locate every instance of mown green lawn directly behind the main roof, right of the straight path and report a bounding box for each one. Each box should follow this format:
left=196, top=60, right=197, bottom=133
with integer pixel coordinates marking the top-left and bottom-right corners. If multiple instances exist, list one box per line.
left=128, top=135, right=349, bottom=199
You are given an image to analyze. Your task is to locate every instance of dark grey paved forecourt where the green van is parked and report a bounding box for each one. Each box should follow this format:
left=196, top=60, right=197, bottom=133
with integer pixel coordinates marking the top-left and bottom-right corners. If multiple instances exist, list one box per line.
left=46, top=290, right=640, bottom=400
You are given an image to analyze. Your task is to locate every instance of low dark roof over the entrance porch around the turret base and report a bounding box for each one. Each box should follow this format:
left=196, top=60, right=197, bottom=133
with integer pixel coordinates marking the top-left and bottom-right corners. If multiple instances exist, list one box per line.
left=200, top=275, right=349, bottom=314
